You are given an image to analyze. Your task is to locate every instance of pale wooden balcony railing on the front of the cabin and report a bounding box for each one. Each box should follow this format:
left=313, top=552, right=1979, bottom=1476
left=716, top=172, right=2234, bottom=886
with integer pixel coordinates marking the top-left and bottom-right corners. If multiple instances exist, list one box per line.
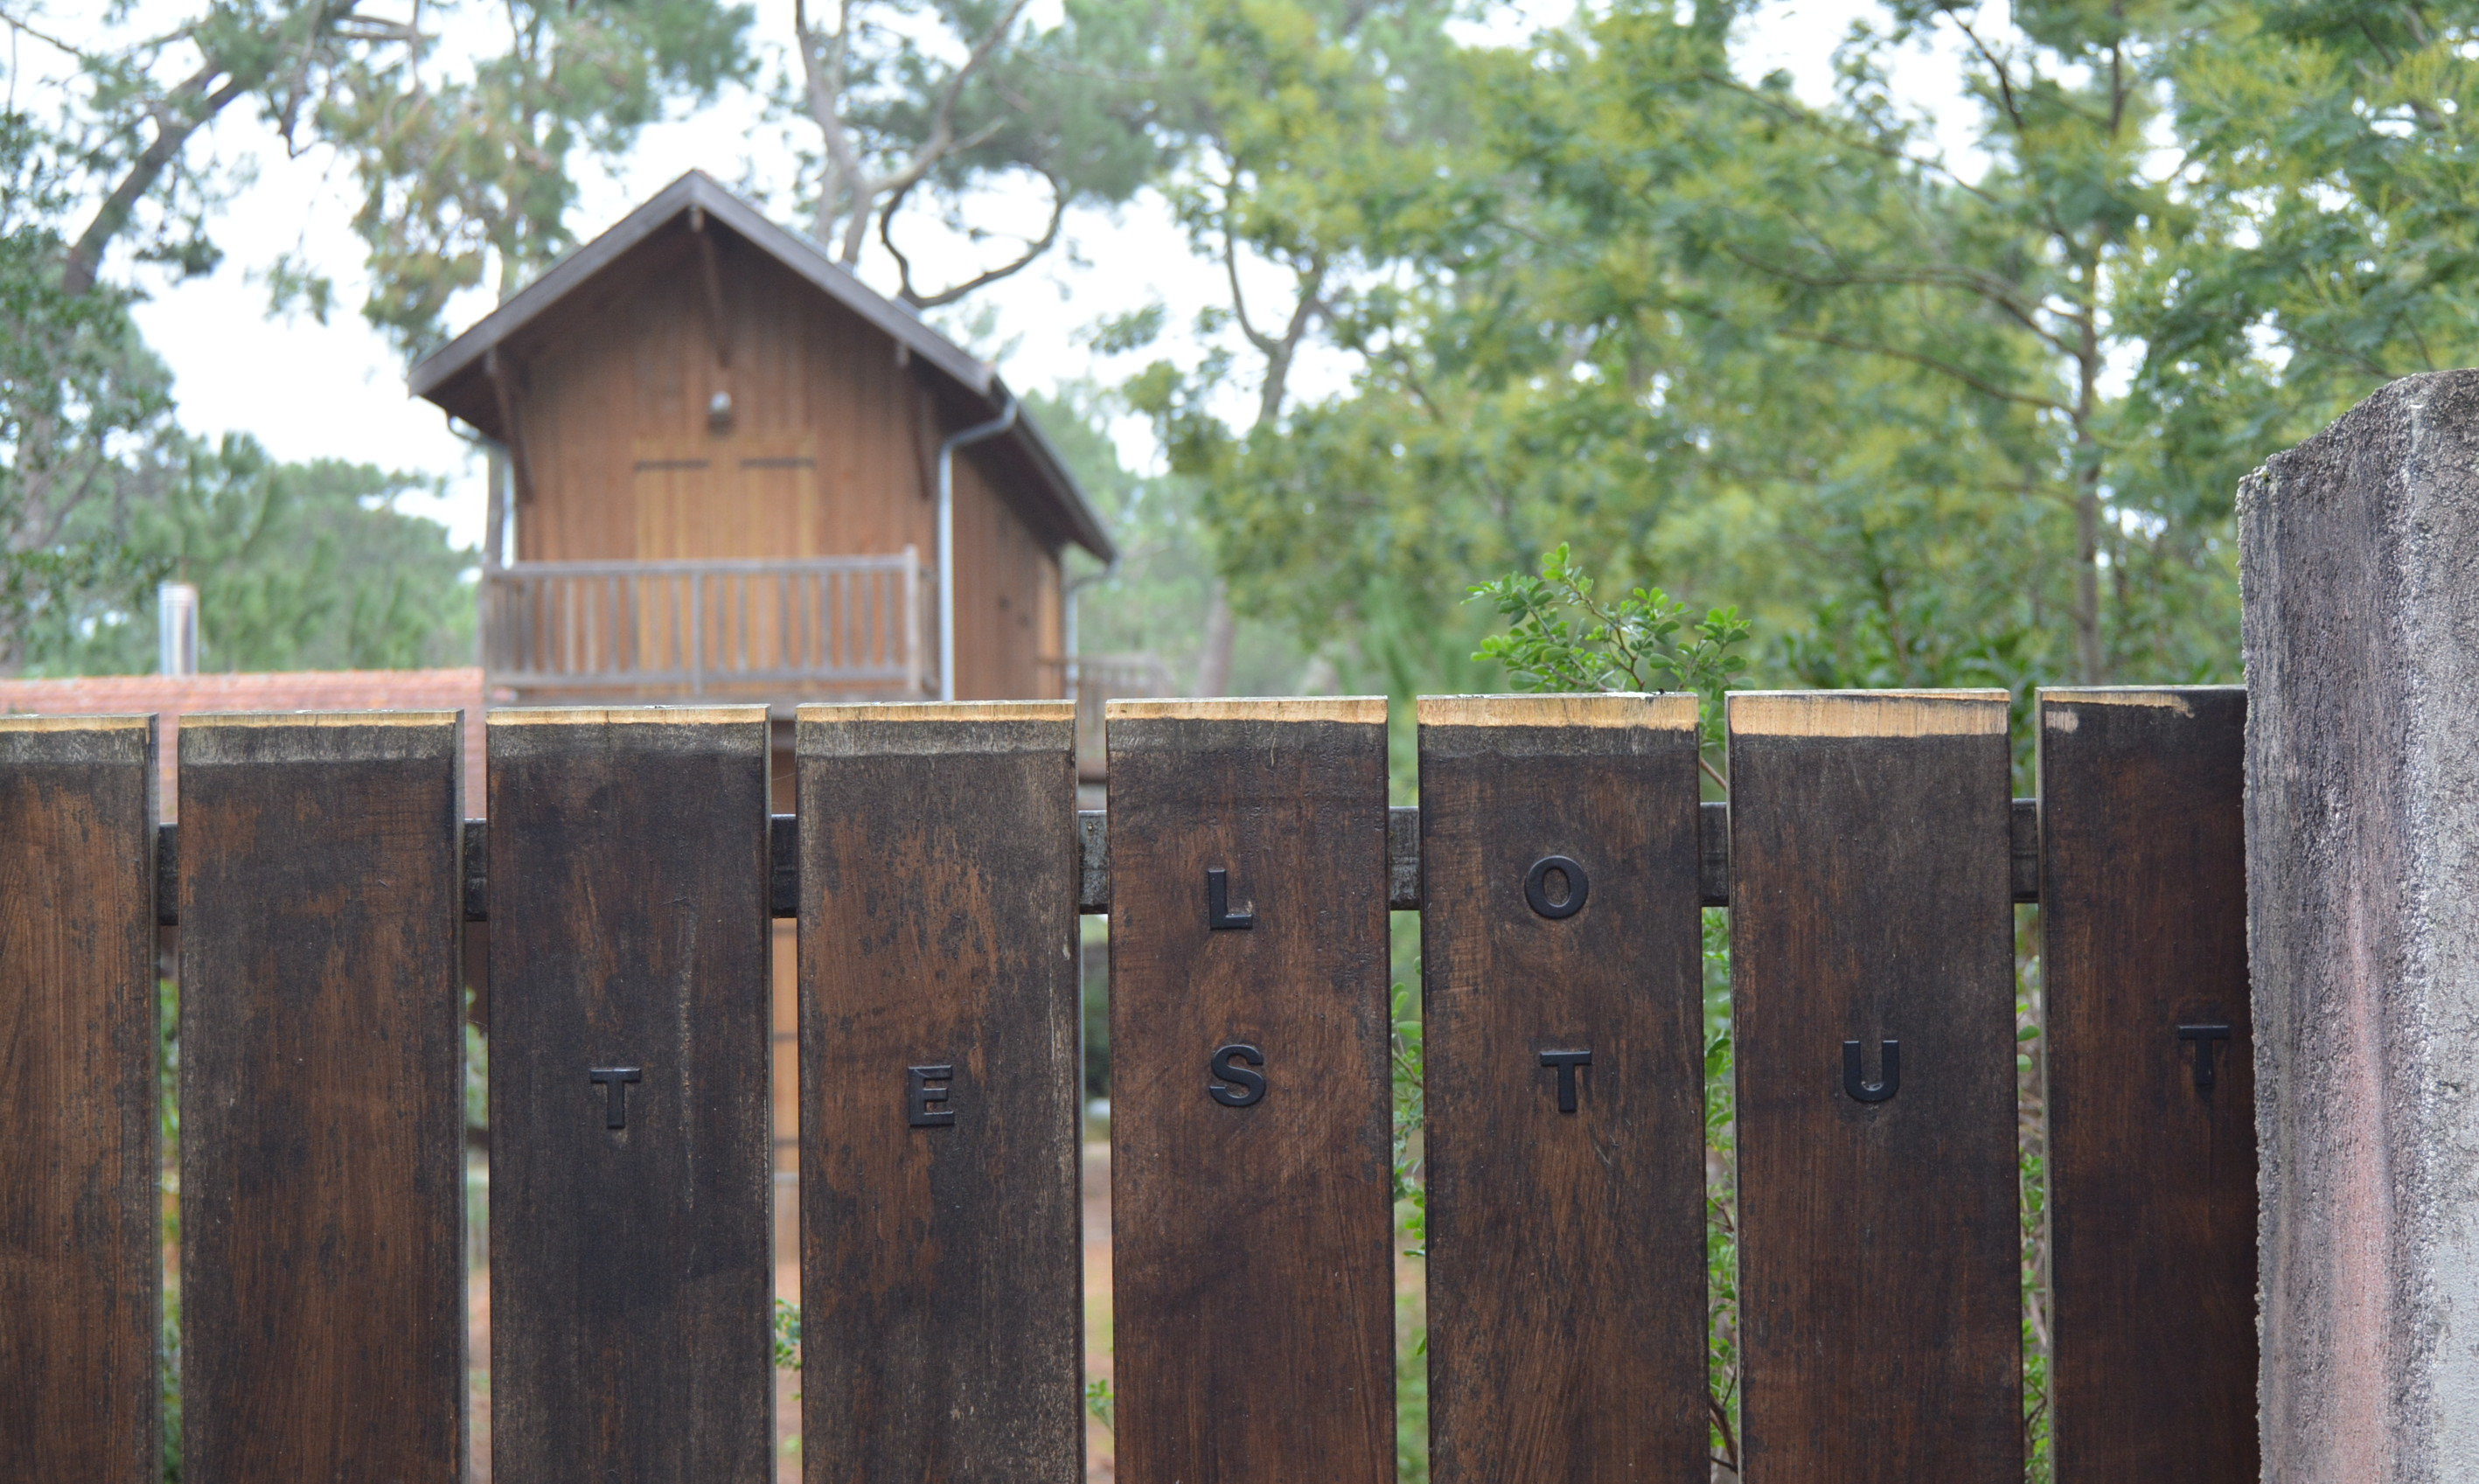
left=481, top=547, right=937, bottom=699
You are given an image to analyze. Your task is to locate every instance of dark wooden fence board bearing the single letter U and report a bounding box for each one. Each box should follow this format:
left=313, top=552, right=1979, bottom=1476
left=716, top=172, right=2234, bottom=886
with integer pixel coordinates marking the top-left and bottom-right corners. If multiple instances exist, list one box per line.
left=1730, top=691, right=2023, bottom=1484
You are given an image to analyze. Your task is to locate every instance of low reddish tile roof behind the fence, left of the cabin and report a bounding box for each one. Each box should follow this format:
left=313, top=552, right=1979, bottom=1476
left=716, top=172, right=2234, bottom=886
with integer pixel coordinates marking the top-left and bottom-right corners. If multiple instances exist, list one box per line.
left=0, top=669, right=484, bottom=820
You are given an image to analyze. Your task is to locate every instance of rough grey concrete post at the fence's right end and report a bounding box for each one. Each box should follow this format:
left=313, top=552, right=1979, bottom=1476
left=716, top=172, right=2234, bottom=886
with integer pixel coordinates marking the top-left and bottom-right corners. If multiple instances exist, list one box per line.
left=2239, top=372, right=2479, bottom=1484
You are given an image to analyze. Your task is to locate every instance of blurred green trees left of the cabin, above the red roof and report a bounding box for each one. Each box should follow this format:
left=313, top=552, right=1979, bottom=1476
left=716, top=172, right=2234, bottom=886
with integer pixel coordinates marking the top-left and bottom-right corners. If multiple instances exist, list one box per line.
left=32, top=436, right=476, bottom=674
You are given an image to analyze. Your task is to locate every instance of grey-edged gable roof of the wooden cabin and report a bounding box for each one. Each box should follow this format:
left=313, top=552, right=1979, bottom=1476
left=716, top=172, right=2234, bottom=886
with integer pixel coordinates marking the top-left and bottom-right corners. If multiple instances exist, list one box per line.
left=407, top=171, right=1118, bottom=562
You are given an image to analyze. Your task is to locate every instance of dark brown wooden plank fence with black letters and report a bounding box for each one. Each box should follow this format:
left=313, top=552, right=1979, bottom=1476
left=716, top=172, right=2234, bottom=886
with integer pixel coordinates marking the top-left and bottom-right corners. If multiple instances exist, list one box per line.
left=0, top=689, right=2256, bottom=1484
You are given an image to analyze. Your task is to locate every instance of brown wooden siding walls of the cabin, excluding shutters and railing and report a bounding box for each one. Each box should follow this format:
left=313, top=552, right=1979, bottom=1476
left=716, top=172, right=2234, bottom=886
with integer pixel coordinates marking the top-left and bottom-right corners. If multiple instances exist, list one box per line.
left=516, top=228, right=1061, bottom=699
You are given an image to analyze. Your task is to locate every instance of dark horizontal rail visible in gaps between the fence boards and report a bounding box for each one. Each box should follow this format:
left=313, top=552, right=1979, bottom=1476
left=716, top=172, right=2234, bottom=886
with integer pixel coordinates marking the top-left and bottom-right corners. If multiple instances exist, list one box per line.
left=157, top=798, right=2040, bottom=927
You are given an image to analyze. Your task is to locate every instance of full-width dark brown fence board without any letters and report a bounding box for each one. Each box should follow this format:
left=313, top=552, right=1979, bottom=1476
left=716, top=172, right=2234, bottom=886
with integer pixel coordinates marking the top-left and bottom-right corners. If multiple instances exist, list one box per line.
left=181, top=711, right=466, bottom=1484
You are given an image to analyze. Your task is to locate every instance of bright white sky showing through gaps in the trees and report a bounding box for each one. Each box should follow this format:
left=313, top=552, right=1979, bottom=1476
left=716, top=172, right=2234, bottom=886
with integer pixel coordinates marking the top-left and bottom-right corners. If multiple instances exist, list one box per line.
left=15, top=0, right=1968, bottom=545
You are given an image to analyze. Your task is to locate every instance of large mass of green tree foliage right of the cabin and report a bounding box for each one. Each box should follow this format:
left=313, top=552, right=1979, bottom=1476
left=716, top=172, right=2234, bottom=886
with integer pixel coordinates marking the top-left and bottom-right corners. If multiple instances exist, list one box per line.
left=1155, top=0, right=2479, bottom=713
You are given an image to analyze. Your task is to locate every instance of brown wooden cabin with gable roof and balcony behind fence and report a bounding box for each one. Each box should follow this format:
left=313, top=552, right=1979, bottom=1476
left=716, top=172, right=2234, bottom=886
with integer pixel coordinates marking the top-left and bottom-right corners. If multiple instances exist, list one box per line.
left=412, top=171, right=1113, bottom=706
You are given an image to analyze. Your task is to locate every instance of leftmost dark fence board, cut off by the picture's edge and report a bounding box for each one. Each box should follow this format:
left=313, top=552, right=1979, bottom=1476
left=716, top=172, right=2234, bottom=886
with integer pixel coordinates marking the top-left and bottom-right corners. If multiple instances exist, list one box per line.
left=0, top=716, right=164, bottom=1484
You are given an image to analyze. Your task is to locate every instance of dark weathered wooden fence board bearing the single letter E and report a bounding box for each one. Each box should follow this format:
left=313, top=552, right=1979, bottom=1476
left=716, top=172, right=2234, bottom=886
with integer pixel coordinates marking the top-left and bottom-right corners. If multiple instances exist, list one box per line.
left=798, top=701, right=1083, bottom=1484
